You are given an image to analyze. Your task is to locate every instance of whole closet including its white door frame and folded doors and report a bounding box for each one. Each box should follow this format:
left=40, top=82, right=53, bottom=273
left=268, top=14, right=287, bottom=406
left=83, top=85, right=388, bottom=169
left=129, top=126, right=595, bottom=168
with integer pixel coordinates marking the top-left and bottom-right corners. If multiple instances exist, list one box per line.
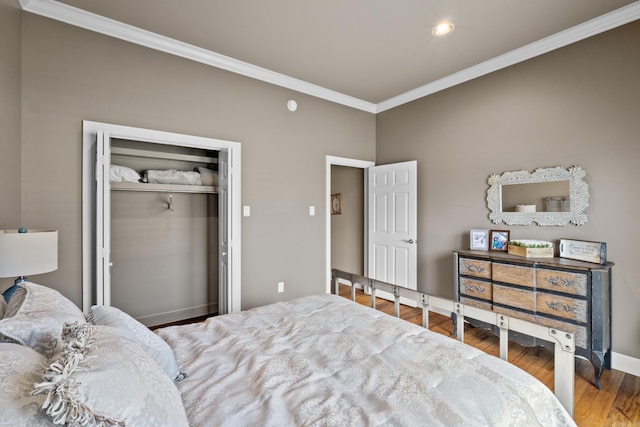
left=83, top=122, right=240, bottom=326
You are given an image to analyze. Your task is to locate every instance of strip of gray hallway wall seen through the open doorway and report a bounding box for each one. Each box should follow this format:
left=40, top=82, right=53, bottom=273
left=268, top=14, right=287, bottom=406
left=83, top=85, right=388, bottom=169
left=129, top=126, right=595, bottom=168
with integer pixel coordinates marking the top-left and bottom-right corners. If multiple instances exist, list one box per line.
left=331, top=165, right=364, bottom=274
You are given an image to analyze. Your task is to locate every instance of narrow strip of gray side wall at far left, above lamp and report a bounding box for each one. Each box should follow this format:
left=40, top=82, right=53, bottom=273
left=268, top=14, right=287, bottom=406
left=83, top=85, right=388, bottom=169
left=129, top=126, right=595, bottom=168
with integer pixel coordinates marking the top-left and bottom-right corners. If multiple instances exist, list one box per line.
left=0, top=0, right=22, bottom=291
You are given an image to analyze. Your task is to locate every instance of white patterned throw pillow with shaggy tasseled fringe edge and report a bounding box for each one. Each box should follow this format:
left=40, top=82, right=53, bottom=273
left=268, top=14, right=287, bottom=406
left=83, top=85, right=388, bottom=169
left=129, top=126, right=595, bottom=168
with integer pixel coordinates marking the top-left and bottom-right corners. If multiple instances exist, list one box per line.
left=33, top=322, right=188, bottom=427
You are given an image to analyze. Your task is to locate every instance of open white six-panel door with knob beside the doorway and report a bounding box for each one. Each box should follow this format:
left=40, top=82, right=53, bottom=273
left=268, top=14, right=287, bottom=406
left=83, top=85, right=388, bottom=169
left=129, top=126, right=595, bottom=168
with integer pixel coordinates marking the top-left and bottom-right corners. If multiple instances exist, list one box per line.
left=366, top=161, right=418, bottom=296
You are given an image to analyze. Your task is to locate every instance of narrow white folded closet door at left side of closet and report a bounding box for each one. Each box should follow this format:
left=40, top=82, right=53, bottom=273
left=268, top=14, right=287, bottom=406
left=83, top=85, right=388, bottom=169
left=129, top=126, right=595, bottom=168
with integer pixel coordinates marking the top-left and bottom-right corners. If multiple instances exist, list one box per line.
left=95, top=131, right=111, bottom=305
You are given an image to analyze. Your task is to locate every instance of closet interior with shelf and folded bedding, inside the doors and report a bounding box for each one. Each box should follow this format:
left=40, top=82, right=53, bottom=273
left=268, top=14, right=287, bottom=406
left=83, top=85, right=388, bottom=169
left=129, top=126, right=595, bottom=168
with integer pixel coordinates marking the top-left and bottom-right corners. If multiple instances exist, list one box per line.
left=110, top=138, right=219, bottom=326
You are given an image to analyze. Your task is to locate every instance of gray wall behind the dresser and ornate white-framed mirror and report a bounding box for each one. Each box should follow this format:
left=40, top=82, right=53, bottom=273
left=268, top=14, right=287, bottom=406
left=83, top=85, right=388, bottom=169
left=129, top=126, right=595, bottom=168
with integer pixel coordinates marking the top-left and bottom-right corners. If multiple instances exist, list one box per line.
left=376, top=22, right=640, bottom=358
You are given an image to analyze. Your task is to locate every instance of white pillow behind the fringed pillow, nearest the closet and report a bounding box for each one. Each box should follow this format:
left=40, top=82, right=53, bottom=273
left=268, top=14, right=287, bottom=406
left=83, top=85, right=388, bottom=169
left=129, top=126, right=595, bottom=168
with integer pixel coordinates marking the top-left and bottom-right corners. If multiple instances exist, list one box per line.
left=88, top=305, right=186, bottom=381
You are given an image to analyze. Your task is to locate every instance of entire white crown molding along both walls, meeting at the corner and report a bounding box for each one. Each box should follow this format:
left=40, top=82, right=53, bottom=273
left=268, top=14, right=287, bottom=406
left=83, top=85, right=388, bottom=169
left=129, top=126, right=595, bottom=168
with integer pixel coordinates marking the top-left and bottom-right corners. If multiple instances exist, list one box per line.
left=20, top=0, right=640, bottom=114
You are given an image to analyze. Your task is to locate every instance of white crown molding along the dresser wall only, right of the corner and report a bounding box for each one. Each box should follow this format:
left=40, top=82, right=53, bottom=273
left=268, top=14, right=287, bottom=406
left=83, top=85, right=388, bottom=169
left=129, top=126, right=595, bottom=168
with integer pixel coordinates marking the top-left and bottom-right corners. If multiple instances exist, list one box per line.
left=376, top=1, right=640, bottom=113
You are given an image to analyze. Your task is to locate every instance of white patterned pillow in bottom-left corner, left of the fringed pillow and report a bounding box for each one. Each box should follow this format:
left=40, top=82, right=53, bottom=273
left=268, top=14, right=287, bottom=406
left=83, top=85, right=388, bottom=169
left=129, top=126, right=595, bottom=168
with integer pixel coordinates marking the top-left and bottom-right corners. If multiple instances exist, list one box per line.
left=0, top=343, right=53, bottom=427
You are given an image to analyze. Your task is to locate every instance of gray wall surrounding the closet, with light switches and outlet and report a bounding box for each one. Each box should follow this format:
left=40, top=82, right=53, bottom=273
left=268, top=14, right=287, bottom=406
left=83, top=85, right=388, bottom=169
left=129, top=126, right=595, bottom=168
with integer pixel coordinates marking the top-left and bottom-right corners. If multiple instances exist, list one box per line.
left=12, top=13, right=375, bottom=308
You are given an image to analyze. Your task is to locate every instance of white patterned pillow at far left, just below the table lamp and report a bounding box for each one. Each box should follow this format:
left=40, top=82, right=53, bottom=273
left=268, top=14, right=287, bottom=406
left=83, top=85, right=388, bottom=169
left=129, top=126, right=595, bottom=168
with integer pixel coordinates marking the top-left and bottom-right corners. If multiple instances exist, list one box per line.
left=0, top=282, right=85, bottom=357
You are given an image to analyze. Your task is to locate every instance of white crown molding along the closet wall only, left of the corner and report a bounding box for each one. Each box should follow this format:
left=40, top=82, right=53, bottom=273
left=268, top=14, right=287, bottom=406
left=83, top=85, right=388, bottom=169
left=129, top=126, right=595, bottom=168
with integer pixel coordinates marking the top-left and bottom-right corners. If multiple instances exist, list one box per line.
left=20, top=0, right=376, bottom=113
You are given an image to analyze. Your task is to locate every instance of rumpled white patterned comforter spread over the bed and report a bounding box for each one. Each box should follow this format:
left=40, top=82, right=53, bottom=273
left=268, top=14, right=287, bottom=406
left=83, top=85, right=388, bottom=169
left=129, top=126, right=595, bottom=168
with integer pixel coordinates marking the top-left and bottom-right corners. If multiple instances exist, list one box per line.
left=157, top=295, right=575, bottom=427
